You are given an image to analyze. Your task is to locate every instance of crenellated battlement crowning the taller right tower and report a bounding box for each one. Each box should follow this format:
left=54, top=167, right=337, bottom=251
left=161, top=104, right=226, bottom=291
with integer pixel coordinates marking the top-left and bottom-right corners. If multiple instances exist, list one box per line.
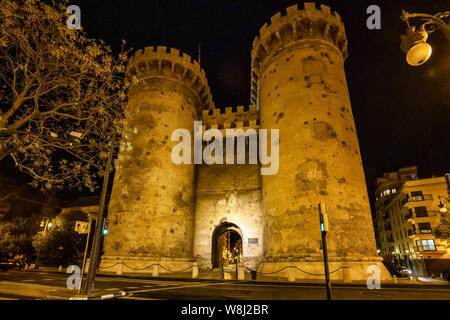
left=250, top=2, right=347, bottom=103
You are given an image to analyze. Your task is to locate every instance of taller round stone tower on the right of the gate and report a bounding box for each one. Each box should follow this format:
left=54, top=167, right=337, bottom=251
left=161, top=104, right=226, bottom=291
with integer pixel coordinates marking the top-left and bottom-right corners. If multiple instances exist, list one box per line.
left=251, top=3, right=388, bottom=278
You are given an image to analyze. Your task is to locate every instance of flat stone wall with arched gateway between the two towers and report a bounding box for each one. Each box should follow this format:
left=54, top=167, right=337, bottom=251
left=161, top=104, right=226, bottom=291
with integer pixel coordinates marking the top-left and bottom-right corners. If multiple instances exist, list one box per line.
left=194, top=105, right=263, bottom=268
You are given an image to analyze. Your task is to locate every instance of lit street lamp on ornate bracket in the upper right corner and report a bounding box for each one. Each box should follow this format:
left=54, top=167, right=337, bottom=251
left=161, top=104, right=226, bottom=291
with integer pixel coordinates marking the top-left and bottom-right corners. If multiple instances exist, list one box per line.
left=400, top=10, right=450, bottom=66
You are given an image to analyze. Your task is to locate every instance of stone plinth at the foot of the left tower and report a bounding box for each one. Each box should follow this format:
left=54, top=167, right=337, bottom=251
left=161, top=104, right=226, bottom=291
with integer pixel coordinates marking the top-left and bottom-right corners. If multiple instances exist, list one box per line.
left=99, top=255, right=195, bottom=273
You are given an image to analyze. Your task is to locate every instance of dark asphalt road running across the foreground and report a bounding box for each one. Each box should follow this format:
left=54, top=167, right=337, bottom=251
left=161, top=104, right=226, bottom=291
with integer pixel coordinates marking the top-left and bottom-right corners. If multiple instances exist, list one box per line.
left=0, top=270, right=450, bottom=300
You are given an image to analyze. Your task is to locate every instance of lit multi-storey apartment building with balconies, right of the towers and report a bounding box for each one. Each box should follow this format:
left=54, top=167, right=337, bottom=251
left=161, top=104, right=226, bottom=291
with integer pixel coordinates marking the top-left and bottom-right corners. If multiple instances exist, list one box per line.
left=375, top=167, right=450, bottom=276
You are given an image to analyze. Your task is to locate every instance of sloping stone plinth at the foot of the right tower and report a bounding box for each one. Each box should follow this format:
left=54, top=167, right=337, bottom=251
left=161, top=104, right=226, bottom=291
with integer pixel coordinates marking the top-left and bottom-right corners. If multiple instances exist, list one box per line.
left=258, top=259, right=392, bottom=282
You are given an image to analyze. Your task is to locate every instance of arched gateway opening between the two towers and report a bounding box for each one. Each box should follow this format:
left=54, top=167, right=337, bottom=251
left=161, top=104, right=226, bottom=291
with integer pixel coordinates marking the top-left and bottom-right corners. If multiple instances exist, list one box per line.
left=211, top=222, right=244, bottom=269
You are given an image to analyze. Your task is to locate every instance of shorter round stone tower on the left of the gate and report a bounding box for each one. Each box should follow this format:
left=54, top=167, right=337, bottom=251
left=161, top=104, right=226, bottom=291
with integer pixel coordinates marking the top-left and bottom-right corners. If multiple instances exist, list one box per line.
left=102, top=47, right=214, bottom=271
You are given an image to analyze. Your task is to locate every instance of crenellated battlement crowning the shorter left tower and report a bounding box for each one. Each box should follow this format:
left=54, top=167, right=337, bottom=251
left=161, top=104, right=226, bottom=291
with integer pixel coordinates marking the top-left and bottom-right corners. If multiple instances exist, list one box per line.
left=127, top=46, right=214, bottom=109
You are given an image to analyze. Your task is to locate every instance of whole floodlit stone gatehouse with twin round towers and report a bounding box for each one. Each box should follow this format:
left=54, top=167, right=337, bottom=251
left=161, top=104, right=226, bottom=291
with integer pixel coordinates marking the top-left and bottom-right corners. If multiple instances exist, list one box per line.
left=100, top=3, right=390, bottom=280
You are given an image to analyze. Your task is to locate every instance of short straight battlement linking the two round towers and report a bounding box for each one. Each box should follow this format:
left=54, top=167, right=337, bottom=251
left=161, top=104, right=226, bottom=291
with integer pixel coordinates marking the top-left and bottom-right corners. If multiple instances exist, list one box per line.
left=202, top=105, right=259, bottom=133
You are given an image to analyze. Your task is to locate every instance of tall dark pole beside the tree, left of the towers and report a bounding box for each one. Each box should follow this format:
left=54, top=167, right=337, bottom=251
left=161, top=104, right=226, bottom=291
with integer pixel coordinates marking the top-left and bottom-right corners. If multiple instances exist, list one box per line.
left=85, top=131, right=116, bottom=296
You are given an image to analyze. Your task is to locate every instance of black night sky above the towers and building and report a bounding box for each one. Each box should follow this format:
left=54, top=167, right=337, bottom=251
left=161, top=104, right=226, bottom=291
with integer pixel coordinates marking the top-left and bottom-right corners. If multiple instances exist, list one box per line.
left=0, top=0, right=450, bottom=205
